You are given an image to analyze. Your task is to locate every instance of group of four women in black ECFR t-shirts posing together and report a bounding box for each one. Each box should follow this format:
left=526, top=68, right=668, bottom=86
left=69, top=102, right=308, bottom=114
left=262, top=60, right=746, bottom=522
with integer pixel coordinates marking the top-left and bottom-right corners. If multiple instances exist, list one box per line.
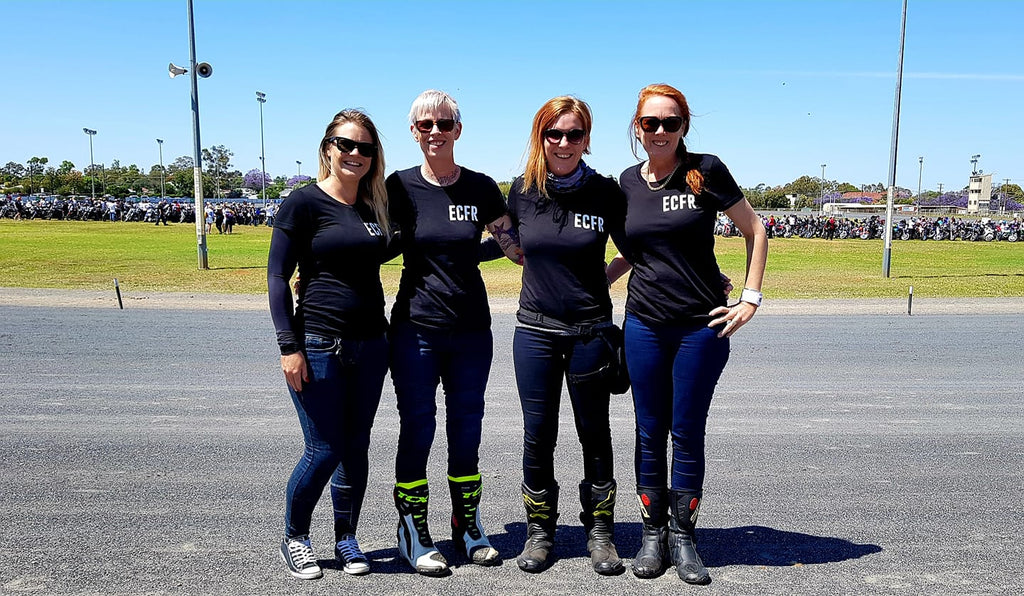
left=268, top=85, right=767, bottom=583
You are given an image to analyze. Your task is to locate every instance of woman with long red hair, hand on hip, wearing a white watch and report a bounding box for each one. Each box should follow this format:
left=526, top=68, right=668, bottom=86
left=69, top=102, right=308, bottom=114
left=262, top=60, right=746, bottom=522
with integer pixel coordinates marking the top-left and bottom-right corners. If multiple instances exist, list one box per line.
left=608, top=84, right=768, bottom=584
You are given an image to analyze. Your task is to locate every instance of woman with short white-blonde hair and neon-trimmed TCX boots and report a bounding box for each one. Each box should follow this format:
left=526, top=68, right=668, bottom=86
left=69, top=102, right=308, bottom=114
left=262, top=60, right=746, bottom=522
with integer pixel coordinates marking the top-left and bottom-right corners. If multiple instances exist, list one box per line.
left=387, top=89, right=521, bottom=576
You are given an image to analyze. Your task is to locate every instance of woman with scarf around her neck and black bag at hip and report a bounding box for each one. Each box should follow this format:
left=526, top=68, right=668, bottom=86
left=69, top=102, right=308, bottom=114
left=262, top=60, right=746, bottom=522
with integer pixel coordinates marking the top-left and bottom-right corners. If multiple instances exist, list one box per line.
left=508, top=96, right=626, bottom=574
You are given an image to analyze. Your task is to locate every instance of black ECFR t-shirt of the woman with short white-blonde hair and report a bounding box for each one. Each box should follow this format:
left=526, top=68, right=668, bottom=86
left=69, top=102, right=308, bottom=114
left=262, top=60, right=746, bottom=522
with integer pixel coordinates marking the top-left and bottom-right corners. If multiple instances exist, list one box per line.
left=387, top=166, right=505, bottom=330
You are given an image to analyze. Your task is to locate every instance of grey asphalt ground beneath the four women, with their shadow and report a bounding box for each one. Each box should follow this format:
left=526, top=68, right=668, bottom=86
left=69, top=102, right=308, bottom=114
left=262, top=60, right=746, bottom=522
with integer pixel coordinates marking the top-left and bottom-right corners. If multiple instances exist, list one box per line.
left=0, top=300, right=1024, bottom=595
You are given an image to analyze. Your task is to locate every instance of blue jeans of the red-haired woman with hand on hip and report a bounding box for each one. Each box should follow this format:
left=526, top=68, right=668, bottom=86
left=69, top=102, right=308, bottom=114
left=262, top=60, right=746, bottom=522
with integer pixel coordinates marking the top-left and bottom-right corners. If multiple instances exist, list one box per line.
left=625, top=312, right=729, bottom=491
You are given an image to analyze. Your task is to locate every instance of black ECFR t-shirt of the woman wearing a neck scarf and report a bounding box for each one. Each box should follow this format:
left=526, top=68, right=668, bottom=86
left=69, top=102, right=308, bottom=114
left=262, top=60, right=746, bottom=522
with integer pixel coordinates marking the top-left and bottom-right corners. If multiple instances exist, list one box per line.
left=509, top=174, right=626, bottom=325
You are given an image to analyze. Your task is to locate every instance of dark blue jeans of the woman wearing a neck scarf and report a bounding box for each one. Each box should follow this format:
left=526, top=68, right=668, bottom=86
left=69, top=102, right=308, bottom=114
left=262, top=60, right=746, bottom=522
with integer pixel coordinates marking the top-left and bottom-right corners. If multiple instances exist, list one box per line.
left=512, top=327, right=613, bottom=491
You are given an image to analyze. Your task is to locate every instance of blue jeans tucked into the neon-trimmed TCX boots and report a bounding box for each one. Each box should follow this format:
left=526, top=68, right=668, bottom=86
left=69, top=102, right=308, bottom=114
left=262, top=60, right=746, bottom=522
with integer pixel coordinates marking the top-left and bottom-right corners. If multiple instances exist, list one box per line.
left=389, top=322, right=494, bottom=482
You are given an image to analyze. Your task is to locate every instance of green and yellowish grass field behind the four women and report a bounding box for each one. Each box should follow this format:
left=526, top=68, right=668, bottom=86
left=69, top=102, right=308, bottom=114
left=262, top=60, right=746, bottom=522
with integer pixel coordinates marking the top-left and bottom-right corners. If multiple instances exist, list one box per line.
left=0, top=220, right=1024, bottom=298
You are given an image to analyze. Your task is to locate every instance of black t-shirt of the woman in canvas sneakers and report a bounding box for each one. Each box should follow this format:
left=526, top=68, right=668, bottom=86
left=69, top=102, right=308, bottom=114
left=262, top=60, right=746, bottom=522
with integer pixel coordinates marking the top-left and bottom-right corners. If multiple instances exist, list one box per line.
left=273, top=184, right=387, bottom=339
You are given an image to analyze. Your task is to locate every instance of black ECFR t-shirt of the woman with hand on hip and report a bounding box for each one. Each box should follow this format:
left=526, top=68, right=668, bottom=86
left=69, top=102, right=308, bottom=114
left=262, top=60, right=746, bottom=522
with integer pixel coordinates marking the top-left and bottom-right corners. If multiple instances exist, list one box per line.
left=618, top=154, right=743, bottom=325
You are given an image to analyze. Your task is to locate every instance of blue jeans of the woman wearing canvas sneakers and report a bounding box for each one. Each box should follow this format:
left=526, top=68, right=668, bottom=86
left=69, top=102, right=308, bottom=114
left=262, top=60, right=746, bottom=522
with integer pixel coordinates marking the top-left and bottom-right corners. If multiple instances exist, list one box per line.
left=285, top=334, right=387, bottom=540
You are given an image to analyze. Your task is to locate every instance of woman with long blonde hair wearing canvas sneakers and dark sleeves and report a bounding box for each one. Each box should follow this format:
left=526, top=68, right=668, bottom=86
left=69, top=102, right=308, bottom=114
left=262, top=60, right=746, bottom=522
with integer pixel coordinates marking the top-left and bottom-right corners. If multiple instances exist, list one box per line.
left=267, top=110, right=390, bottom=580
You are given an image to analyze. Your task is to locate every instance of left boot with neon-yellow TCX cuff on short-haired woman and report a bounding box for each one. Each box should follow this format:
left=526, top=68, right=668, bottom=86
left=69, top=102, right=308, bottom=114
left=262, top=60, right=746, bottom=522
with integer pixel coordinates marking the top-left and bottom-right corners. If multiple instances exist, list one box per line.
left=394, top=478, right=449, bottom=576
